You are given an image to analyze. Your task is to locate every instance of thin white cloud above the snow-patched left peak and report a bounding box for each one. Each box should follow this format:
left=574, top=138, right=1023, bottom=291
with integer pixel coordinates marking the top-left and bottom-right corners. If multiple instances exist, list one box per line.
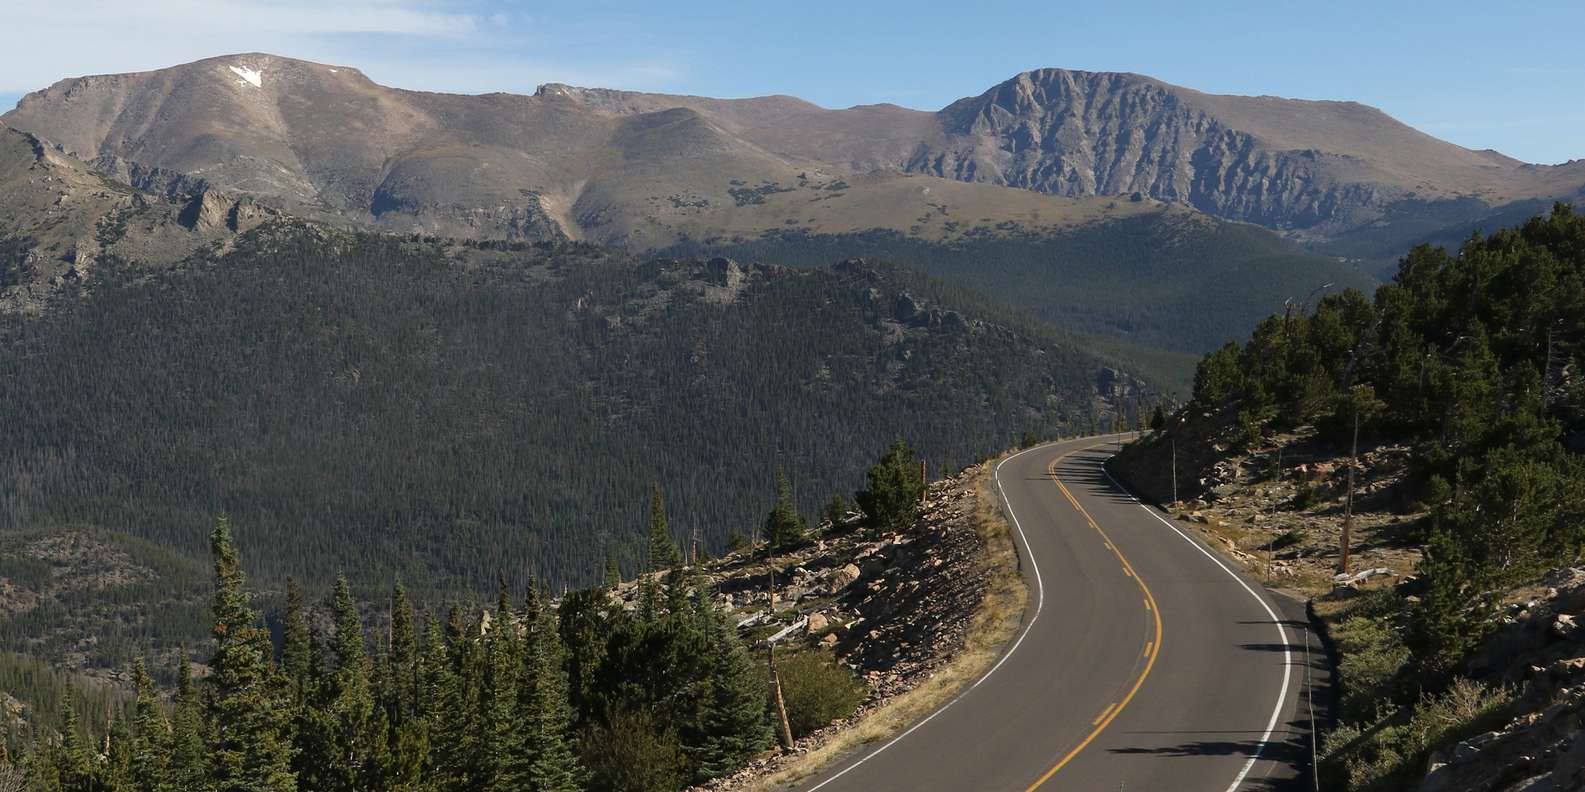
left=0, top=0, right=680, bottom=95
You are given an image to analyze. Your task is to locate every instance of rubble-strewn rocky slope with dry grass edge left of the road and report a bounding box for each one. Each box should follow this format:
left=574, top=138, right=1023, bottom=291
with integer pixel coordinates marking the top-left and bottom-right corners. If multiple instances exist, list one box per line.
left=659, top=466, right=1025, bottom=790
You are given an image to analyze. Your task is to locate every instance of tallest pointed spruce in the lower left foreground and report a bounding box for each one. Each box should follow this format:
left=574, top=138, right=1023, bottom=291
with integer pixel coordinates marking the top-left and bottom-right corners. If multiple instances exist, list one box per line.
left=208, top=518, right=296, bottom=792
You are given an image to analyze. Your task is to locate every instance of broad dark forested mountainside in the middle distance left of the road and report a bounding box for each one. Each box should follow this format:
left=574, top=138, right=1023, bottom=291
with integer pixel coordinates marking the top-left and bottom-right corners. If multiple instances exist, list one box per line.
left=0, top=225, right=1149, bottom=667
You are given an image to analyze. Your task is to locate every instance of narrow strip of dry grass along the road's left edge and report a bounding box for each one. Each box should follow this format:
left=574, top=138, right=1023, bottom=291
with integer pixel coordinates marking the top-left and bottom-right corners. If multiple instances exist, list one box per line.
left=743, top=461, right=1027, bottom=790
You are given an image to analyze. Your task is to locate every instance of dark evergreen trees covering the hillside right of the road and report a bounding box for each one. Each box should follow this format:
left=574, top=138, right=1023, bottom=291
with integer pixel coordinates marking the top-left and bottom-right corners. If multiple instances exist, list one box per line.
left=1194, top=204, right=1585, bottom=779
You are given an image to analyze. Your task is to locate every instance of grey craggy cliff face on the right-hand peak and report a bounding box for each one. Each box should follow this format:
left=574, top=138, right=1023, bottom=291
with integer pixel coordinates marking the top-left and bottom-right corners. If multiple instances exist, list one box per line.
left=905, top=70, right=1401, bottom=228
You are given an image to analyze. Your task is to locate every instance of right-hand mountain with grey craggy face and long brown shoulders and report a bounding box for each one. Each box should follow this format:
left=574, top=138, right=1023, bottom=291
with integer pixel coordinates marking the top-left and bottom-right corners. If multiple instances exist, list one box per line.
left=556, top=68, right=1585, bottom=255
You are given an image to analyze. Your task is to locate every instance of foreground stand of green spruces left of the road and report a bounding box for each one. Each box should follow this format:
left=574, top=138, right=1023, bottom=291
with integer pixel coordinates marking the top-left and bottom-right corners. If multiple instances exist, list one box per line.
left=0, top=501, right=874, bottom=792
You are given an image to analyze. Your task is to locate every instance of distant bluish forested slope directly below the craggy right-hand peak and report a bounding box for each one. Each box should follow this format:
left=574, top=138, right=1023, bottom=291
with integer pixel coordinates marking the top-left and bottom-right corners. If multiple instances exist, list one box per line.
left=656, top=215, right=1374, bottom=355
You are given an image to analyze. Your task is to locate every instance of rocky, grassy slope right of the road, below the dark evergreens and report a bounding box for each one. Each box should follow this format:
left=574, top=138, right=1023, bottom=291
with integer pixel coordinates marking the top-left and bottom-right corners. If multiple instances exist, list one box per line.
left=1113, top=413, right=1585, bottom=792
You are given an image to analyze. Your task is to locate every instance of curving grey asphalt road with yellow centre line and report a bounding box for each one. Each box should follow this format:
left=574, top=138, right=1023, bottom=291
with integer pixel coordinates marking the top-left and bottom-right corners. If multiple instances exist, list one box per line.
left=799, top=439, right=1322, bottom=792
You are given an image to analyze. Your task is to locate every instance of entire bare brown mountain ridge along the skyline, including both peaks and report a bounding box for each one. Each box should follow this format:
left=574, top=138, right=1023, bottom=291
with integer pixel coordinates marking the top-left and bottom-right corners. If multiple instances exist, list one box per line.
left=0, top=54, right=1585, bottom=255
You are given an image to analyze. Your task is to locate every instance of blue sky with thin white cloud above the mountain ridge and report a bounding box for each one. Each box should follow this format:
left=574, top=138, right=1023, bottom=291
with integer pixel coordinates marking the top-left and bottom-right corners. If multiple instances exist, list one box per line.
left=9, top=0, right=1585, bottom=163
